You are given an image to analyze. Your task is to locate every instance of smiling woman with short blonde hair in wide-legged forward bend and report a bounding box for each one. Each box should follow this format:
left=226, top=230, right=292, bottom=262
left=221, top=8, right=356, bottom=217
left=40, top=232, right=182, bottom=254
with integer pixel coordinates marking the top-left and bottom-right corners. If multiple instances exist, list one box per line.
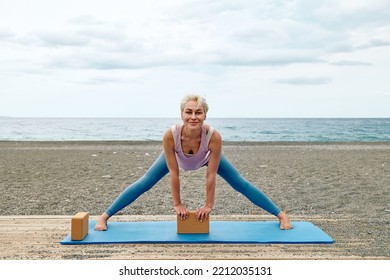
left=95, top=95, right=292, bottom=230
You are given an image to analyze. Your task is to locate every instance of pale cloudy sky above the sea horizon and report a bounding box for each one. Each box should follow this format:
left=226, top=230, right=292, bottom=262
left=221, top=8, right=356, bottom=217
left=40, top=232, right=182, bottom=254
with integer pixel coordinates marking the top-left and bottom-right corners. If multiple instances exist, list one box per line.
left=0, top=0, right=390, bottom=118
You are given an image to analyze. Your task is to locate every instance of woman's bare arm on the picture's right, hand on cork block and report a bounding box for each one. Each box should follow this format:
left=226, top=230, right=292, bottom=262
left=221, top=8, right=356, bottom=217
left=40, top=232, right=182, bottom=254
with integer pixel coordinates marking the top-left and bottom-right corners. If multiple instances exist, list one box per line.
left=196, top=131, right=222, bottom=221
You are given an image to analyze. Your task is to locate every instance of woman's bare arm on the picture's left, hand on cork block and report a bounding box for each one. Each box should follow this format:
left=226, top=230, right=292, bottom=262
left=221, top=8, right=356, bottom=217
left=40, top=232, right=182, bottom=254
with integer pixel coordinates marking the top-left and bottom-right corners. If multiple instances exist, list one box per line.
left=163, top=129, right=189, bottom=219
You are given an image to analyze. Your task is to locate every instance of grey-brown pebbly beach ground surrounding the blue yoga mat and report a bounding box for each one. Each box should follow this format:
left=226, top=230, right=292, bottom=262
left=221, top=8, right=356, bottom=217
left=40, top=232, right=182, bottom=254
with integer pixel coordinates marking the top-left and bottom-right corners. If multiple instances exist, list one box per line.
left=0, top=141, right=390, bottom=259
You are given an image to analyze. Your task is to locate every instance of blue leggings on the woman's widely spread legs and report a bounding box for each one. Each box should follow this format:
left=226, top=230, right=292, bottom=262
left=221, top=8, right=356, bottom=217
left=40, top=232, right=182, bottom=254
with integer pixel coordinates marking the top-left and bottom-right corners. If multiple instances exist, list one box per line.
left=106, top=153, right=280, bottom=217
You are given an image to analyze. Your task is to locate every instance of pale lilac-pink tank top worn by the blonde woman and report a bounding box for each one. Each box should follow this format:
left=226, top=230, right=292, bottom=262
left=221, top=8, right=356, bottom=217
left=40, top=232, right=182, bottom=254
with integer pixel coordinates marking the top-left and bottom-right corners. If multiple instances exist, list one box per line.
left=172, top=124, right=214, bottom=170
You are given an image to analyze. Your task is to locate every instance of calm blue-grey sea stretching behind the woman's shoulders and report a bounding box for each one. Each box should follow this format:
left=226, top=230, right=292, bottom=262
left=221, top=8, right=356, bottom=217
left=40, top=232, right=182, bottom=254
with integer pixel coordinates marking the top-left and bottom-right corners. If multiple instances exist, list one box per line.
left=0, top=117, right=390, bottom=142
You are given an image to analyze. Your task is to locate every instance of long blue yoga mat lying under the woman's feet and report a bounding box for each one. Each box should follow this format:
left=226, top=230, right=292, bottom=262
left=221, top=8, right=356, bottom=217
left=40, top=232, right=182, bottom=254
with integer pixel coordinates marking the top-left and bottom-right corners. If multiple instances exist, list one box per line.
left=60, top=221, right=334, bottom=245
